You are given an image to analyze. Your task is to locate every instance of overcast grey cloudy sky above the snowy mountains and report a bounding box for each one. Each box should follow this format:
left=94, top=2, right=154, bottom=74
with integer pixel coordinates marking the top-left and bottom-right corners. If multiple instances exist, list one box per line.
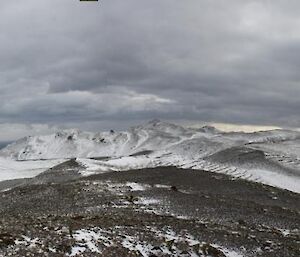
left=0, top=0, right=300, bottom=141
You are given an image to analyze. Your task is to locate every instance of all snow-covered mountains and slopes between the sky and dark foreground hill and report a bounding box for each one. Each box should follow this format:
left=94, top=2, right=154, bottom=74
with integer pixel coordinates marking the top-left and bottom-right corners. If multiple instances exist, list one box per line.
left=0, top=120, right=300, bottom=193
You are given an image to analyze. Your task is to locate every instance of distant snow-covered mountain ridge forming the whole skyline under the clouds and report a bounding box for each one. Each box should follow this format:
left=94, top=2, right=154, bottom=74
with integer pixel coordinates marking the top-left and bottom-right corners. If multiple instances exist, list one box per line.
left=0, top=119, right=300, bottom=160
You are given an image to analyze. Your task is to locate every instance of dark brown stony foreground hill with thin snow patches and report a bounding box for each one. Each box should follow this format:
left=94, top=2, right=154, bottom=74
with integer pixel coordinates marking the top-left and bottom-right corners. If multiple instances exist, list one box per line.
left=0, top=161, right=300, bottom=257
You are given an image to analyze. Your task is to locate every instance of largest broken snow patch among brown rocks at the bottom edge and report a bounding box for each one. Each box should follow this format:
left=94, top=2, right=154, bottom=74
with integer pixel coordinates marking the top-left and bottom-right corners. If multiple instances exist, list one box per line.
left=69, top=226, right=243, bottom=257
